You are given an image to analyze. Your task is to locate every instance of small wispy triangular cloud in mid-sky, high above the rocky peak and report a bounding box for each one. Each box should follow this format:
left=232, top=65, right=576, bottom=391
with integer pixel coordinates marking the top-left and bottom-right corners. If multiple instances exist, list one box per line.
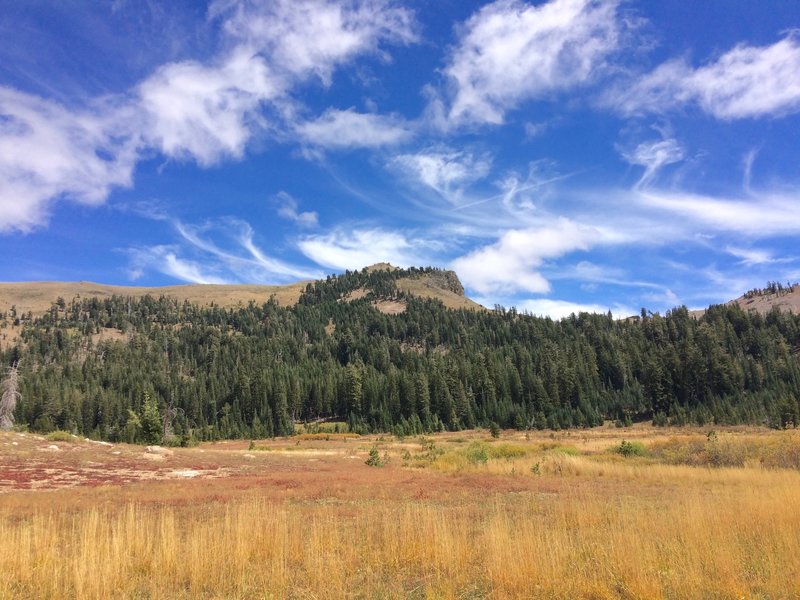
left=391, top=148, right=492, bottom=204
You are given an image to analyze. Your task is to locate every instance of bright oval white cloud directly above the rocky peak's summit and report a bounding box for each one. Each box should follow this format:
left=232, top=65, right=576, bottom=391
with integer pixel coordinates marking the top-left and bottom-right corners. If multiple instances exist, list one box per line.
left=298, top=229, right=431, bottom=270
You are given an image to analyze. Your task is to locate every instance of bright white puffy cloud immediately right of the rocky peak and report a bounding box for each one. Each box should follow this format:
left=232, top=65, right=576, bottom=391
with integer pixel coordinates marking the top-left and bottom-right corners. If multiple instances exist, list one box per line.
left=452, top=218, right=603, bottom=295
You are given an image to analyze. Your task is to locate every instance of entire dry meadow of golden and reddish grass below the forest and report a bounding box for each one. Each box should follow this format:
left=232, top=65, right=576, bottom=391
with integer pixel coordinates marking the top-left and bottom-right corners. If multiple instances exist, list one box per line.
left=0, top=426, right=800, bottom=599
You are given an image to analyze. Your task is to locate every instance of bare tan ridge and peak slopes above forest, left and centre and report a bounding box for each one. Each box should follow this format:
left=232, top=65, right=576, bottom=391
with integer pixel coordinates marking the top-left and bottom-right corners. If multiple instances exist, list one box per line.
left=0, top=263, right=485, bottom=316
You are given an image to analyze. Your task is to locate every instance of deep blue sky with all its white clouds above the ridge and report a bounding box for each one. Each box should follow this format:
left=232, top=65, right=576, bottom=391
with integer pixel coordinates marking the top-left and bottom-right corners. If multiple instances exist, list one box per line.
left=0, top=0, right=800, bottom=318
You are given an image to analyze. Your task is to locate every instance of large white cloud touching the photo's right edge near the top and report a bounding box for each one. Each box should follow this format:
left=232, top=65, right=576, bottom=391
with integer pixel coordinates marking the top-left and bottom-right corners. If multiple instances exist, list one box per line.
left=606, top=33, right=800, bottom=120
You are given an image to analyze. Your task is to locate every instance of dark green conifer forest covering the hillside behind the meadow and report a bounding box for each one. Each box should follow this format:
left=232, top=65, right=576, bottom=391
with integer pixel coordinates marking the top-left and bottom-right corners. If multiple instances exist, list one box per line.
left=2, top=269, right=800, bottom=442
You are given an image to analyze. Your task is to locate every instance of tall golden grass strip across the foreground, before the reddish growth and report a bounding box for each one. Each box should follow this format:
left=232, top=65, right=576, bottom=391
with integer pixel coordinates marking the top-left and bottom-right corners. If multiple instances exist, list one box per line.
left=0, top=480, right=800, bottom=598
